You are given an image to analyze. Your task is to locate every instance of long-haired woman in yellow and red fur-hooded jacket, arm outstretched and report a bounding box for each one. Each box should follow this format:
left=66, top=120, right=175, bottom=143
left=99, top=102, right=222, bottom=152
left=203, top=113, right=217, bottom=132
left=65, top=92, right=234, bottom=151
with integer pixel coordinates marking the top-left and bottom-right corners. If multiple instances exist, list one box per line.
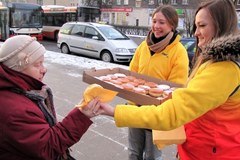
left=92, top=0, right=240, bottom=160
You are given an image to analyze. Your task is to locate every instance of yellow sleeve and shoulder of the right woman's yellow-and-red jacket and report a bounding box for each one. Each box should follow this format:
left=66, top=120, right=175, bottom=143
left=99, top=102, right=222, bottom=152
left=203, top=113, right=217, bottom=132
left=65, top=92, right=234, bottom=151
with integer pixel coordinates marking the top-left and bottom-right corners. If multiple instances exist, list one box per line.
left=114, top=61, right=240, bottom=130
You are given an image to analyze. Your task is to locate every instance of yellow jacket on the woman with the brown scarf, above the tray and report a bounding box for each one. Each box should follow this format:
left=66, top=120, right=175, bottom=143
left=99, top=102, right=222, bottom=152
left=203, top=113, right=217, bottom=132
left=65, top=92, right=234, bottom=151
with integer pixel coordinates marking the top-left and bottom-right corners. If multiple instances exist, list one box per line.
left=129, top=35, right=189, bottom=84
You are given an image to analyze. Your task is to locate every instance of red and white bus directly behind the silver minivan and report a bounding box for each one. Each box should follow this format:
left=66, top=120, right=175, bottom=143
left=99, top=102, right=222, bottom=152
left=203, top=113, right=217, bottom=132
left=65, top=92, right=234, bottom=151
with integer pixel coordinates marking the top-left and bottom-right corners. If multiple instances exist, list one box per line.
left=42, top=5, right=101, bottom=40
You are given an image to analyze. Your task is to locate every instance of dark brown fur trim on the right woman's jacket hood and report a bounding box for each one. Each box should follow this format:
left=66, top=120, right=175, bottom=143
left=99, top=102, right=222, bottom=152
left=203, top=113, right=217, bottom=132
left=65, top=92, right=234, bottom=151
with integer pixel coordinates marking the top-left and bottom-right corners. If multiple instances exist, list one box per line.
left=203, top=34, right=240, bottom=62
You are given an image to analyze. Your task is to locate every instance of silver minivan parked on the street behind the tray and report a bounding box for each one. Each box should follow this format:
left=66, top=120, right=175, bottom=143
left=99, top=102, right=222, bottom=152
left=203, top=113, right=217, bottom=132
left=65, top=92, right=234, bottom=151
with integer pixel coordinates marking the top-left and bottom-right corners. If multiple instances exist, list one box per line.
left=57, top=22, right=137, bottom=62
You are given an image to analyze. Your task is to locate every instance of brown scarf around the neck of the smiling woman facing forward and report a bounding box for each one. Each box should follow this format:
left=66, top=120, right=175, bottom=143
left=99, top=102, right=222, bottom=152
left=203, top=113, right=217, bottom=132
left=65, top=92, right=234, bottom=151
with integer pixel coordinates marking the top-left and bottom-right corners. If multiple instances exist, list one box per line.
left=146, top=30, right=174, bottom=53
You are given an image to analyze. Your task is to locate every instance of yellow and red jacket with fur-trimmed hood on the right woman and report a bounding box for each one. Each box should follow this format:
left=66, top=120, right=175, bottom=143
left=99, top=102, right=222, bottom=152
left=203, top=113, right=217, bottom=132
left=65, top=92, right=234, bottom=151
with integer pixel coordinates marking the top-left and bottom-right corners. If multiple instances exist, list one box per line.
left=114, top=35, right=240, bottom=160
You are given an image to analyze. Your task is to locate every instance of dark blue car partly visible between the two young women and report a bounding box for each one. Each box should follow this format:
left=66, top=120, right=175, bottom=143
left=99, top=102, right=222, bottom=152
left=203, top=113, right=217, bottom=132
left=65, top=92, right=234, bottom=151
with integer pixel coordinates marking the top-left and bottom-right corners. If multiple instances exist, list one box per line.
left=181, top=38, right=196, bottom=67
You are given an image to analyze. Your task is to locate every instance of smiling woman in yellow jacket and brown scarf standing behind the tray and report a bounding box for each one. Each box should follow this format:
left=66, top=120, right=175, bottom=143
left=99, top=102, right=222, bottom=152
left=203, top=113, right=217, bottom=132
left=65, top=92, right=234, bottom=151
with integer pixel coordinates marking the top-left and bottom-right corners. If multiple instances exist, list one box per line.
left=128, top=5, right=189, bottom=160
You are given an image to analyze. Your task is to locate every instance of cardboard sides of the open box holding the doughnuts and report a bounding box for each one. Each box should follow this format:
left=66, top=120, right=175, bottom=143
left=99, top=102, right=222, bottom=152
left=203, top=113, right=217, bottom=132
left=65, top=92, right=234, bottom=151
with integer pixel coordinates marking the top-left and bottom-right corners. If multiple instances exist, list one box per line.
left=83, top=68, right=182, bottom=105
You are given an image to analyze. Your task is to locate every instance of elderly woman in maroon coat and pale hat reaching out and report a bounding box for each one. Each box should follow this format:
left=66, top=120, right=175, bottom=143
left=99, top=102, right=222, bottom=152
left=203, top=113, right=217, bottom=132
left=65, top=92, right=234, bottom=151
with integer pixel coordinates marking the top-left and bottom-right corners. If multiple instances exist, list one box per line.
left=0, top=35, right=100, bottom=160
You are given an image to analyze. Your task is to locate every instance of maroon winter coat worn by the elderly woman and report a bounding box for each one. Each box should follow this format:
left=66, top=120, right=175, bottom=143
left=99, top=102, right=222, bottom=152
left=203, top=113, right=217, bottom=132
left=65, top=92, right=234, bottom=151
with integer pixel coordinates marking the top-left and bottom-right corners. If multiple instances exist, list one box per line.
left=0, top=64, right=92, bottom=160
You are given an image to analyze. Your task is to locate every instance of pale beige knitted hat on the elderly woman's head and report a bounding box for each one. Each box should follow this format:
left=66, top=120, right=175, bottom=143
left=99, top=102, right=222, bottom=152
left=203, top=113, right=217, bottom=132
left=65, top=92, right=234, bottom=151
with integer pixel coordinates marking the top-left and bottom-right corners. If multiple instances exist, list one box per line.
left=0, top=35, right=46, bottom=71
